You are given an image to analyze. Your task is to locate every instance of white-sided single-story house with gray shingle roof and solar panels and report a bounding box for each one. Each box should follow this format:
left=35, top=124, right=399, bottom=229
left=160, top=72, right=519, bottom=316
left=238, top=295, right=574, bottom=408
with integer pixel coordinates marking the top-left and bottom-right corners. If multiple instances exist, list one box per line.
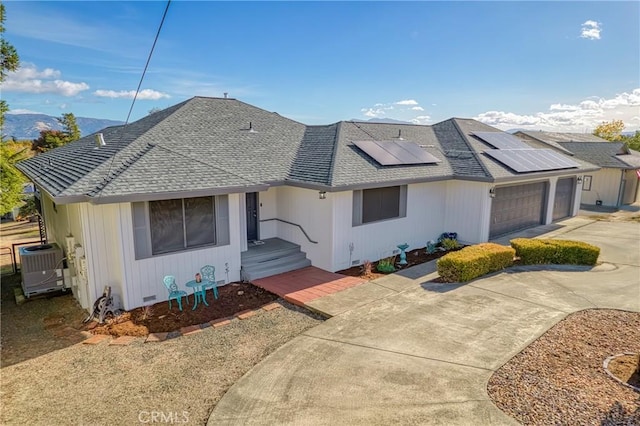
left=18, top=97, right=598, bottom=309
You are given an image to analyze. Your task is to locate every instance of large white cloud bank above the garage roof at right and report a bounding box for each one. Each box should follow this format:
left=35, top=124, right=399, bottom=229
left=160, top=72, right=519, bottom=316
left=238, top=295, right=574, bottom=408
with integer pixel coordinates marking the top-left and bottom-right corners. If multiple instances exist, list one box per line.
left=474, top=88, right=640, bottom=132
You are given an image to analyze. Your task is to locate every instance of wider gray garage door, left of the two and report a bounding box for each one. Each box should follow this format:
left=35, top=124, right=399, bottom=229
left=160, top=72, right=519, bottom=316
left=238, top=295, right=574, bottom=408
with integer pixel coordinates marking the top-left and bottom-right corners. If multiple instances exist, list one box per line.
left=489, top=182, right=547, bottom=238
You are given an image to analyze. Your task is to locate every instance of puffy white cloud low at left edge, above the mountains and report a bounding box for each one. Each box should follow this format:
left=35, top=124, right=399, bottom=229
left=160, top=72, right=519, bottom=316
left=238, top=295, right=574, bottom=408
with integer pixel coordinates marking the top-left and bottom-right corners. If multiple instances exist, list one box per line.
left=2, top=63, right=89, bottom=97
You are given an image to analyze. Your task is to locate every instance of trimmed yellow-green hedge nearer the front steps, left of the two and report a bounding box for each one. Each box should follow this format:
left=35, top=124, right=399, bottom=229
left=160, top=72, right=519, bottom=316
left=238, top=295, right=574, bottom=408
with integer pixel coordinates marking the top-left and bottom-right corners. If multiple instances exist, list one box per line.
left=436, top=243, right=515, bottom=282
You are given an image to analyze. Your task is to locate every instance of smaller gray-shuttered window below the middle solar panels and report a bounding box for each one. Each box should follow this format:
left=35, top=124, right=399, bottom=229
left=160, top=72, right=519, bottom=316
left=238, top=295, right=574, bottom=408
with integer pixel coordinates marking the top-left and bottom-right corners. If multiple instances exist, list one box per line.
left=353, top=185, right=407, bottom=226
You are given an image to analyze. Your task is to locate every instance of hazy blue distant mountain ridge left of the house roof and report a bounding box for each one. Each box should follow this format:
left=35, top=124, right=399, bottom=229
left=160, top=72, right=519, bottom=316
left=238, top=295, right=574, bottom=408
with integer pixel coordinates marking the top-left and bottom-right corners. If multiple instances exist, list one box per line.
left=2, top=114, right=124, bottom=140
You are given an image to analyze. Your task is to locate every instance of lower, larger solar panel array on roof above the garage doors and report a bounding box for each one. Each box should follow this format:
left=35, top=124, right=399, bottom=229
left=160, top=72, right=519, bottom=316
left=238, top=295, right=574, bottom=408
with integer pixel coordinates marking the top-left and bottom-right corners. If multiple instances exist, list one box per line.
left=485, top=148, right=580, bottom=173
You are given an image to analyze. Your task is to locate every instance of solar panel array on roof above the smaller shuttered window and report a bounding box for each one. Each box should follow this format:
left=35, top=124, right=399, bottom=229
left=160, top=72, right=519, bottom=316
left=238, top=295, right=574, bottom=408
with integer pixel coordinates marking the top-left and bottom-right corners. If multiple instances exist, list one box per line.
left=353, top=141, right=440, bottom=166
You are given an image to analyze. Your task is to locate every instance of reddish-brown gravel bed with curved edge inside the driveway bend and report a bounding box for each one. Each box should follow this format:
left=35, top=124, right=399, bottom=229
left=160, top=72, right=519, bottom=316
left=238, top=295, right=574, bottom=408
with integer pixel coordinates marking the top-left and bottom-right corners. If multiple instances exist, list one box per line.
left=488, top=310, right=640, bottom=426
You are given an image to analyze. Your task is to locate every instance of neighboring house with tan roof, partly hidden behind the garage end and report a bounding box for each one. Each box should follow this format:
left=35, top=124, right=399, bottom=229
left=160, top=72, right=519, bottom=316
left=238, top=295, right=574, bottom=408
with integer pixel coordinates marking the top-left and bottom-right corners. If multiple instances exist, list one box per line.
left=514, top=131, right=640, bottom=207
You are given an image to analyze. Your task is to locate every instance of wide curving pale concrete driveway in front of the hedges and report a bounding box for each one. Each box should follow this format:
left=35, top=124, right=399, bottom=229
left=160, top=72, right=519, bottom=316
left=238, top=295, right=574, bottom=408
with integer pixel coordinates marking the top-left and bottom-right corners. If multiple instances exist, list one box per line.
left=208, top=218, right=640, bottom=426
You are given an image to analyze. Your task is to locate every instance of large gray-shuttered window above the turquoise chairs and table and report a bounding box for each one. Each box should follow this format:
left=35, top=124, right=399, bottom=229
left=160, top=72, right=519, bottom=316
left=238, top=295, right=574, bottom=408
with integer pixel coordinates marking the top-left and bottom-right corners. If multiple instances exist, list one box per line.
left=132, top=196, right=229, bottom=259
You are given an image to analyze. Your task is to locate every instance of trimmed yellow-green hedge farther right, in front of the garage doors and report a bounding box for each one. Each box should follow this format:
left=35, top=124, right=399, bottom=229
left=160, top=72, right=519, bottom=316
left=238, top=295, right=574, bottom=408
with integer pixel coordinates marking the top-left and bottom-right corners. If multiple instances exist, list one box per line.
left=510, top=238, right=600, bottom=265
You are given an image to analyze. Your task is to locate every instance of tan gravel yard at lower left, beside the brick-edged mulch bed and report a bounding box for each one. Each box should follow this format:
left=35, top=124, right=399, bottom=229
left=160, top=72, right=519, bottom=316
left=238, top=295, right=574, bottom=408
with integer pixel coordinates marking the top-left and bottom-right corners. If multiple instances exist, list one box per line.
left=0, top=298, right=322, bottom=426
